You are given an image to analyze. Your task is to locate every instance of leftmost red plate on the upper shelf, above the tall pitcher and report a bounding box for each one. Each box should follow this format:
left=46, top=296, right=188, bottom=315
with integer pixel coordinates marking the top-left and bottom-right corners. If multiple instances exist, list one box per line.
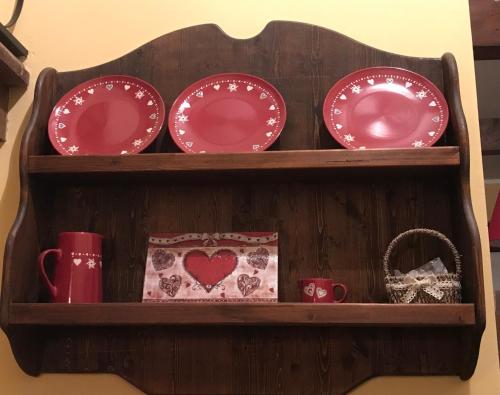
left=49, top=75, right=165, bottom=155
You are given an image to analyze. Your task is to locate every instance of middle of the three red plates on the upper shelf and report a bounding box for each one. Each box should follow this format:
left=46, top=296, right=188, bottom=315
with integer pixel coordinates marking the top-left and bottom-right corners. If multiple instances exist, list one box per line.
left=168, top=73, right=286, bottom=153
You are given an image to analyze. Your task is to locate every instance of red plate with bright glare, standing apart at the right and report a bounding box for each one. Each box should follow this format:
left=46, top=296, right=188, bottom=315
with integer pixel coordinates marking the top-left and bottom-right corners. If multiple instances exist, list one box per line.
left=323, top=67, right=448, bottom=149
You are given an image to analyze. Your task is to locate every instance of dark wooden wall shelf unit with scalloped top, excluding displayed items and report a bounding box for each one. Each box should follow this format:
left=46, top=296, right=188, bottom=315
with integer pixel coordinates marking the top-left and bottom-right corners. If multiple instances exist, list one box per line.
left=0, top=22, right=485, bottom=395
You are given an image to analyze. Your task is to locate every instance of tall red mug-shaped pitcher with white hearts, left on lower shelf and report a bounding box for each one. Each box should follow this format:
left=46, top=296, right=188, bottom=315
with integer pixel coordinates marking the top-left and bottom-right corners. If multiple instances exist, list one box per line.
left=38, top=232, right=103, bottom=303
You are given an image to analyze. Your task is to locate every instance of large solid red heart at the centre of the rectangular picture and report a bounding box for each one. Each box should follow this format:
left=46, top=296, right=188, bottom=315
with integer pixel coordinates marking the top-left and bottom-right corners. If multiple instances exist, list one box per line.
left=184, top=250, right=238, bottom=292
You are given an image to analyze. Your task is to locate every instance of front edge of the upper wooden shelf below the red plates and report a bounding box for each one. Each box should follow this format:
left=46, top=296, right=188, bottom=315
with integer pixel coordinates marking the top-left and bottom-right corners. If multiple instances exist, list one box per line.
left=28, top=147, right=460, bottom=174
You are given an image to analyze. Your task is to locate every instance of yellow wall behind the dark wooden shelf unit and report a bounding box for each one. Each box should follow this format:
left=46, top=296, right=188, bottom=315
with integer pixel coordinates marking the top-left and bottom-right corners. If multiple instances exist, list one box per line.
left=0, top=0, right=500, bottom=395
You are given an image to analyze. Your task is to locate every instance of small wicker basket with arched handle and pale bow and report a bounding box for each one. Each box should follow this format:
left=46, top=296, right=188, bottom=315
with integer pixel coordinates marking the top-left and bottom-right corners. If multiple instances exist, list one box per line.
left=384, top=229, right=462, bottom=303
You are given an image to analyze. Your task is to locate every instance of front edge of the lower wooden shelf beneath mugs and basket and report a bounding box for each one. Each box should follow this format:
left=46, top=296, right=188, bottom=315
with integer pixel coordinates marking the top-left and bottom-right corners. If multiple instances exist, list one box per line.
left=9, top=303, right=475, bottom=326
